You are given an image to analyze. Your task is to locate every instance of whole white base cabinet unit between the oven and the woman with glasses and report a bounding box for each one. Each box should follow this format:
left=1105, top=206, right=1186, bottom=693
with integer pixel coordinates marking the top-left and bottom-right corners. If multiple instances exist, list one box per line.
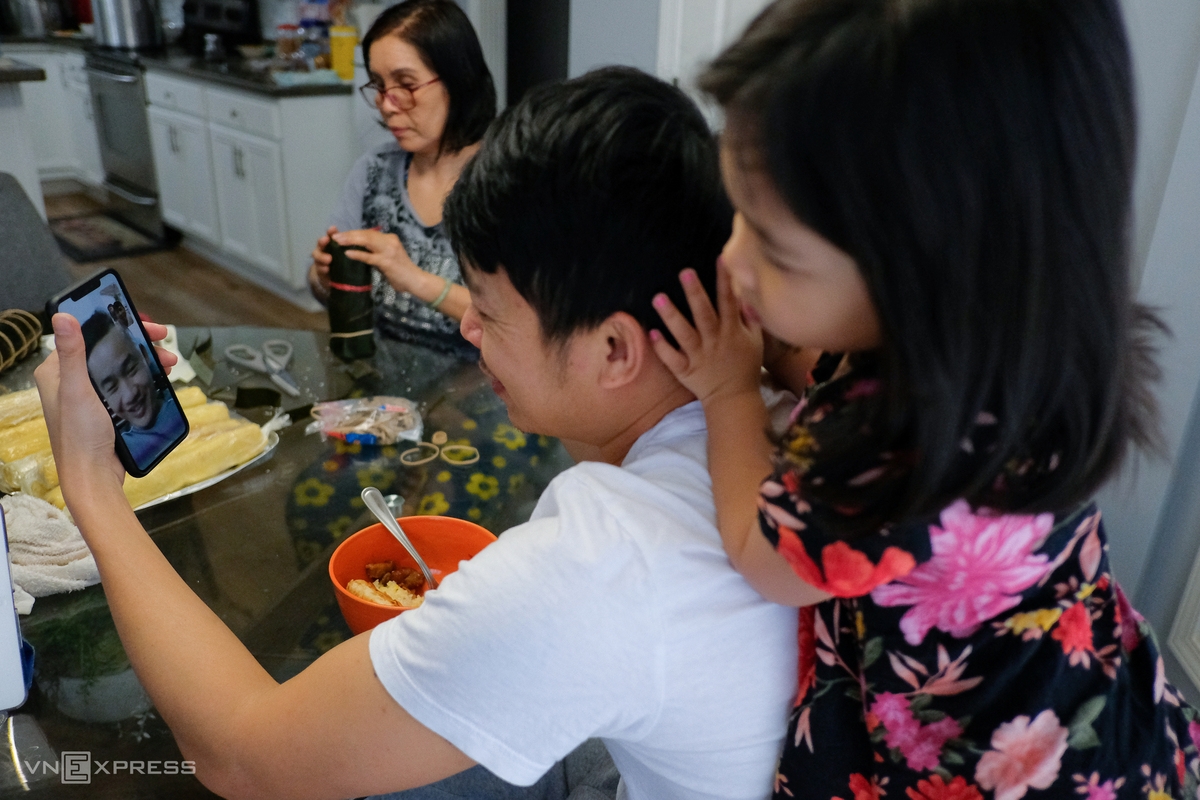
left=146, top=66, right=352, bottom=298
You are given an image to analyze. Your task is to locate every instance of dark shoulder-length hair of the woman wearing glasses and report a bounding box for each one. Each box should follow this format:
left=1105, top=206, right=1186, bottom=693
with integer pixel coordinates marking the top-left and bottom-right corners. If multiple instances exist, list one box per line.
left=362, top=0, right=496, bottom=154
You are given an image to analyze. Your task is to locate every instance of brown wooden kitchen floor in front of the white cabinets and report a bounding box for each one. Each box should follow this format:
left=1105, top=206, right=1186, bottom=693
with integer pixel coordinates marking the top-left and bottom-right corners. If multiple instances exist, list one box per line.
left=43, top=182, right=329, bottom=331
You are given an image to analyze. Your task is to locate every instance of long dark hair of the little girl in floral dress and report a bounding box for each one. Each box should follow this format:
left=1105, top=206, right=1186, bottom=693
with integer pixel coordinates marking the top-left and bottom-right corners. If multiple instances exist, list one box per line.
left=700, top=0, right=1163, bottom=519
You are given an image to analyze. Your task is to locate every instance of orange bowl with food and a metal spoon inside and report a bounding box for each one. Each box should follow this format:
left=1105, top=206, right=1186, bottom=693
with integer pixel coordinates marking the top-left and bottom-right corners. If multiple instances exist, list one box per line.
left=329, top=517, right=496, bottom=633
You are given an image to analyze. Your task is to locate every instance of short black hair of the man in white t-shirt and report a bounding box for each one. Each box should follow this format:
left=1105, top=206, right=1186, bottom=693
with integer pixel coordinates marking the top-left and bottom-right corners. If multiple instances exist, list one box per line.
left=444, top=67, right=732, bottom=342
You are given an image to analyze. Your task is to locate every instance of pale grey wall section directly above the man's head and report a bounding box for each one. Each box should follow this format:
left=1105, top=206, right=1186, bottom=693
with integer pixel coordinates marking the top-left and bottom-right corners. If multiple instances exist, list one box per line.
left=566, top=0, right=659, bottom=78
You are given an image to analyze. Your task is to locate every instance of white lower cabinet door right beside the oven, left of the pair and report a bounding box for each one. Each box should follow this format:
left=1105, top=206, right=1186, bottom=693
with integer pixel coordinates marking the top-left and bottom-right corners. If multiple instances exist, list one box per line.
left=150, top=106, right=221, bottom=243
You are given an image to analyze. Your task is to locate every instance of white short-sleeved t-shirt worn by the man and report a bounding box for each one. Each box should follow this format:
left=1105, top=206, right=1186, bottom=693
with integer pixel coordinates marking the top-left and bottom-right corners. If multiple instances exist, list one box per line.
left=371, top=402, right=797, bottom=800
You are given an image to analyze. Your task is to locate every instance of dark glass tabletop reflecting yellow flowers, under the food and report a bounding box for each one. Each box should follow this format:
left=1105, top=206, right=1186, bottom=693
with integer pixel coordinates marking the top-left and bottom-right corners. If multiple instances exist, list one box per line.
left=0, top=327, right=572, bottom=799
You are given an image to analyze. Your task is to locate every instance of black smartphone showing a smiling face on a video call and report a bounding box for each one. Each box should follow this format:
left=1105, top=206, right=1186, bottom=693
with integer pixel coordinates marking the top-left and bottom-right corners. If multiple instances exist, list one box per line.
left=46, top=269, right=187, bottom=477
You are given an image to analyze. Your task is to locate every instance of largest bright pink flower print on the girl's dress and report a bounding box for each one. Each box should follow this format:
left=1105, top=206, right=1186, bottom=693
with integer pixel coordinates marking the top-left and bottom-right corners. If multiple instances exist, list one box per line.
left=871, top=500, right=1054, bottom=645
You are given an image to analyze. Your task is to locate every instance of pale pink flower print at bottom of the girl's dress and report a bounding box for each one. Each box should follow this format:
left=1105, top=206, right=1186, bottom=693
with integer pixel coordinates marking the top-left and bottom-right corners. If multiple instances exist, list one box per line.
left=974, top=709, right=1068, bottom=800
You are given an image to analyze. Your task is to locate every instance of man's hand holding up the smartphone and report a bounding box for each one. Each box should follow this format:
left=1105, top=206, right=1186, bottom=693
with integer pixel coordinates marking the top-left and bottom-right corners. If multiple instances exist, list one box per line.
left=34, top=313, right=178, bottom=503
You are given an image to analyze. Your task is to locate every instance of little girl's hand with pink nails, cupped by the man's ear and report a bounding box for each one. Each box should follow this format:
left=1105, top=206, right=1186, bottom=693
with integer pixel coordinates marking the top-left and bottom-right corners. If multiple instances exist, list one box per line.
left=650, top=260, right=763, bottom=404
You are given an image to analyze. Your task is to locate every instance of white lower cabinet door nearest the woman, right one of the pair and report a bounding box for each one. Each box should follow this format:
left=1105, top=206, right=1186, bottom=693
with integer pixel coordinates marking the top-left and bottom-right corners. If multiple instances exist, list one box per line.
left=209, top=124, right=293, bottom=277
